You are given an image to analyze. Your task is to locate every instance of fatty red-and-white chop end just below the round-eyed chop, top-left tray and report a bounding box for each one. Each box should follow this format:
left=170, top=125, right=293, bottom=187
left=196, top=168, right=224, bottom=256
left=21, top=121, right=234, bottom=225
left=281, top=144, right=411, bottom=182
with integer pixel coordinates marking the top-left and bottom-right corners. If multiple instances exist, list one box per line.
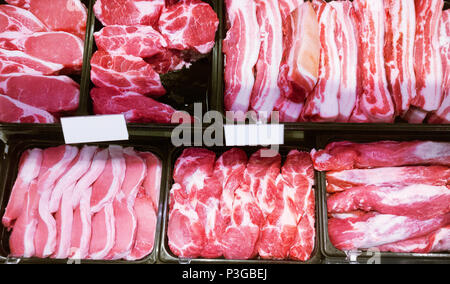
left=0, top=48, right=64, bottom=75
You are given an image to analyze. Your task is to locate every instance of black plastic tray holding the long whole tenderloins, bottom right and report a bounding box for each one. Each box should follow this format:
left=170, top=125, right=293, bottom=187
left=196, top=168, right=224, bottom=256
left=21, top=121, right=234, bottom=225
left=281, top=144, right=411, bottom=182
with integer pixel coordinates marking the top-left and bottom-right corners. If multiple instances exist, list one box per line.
left=316, top=132, right=450, bottom=263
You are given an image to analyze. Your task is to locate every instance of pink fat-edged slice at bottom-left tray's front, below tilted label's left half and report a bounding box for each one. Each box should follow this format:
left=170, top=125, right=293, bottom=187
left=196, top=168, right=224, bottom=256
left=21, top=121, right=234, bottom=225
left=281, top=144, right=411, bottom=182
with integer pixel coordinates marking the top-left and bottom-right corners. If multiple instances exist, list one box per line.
left=69, top=185, right=92, bottom=259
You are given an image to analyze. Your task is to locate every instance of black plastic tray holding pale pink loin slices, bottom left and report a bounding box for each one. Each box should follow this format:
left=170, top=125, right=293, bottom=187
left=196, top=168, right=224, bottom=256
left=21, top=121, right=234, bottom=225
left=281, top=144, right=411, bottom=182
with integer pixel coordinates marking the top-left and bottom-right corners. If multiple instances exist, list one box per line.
left=0, top=134, right=171, bottom=264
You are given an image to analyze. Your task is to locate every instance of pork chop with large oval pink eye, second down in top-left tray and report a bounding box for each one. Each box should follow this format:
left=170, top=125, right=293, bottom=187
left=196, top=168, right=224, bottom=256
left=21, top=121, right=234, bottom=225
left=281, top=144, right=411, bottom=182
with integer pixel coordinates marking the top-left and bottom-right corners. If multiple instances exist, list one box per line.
left=0, top=32, right=84, bottom=73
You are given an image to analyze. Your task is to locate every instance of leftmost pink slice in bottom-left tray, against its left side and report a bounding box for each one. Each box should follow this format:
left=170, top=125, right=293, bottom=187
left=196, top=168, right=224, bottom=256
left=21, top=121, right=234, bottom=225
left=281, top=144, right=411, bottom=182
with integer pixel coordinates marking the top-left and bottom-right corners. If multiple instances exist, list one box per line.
left=2, top=149, right=43, bottom=229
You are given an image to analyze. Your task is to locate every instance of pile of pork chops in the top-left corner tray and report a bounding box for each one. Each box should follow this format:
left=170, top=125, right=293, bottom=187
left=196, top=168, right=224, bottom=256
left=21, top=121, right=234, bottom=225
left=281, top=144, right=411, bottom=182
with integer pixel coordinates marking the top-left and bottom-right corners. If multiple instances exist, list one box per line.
left=0, top=0, right=87, bottom=123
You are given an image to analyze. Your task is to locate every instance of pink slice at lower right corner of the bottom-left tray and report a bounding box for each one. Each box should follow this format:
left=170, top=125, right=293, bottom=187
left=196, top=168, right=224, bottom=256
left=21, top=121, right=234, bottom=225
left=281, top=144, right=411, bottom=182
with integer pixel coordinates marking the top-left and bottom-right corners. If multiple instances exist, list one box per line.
left=127, top=195, right=157, bottom=260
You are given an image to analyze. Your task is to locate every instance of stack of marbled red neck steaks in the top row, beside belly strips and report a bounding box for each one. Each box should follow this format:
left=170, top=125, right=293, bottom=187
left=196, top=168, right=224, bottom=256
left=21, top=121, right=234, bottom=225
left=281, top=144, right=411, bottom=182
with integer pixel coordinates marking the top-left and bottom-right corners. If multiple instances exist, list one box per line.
left=91, top=0, right=219, bottom=123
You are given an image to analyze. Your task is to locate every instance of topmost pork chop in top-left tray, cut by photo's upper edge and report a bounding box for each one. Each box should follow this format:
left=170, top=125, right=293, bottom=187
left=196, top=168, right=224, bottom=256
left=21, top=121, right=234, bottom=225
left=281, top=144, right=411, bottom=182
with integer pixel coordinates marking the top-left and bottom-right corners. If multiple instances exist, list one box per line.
left=6, top=0, right=87, bottom=39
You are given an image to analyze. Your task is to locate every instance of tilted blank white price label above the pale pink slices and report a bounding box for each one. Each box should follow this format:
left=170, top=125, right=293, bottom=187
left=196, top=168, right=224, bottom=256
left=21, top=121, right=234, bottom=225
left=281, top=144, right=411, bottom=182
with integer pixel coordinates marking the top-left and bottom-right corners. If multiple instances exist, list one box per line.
left=61, top=114, right=129, bottom=144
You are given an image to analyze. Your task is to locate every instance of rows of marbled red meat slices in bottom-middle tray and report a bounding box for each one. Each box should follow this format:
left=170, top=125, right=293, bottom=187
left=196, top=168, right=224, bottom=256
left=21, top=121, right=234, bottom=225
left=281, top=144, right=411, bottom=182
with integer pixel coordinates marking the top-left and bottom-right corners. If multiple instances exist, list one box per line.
left=167, top=148, right=316, bottom=261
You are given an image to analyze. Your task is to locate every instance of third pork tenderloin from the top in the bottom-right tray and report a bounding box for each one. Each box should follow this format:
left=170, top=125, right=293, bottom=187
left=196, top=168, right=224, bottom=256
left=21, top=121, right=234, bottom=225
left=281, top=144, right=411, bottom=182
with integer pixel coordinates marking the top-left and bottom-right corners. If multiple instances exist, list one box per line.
left=327, top=184, right=450, bottom=220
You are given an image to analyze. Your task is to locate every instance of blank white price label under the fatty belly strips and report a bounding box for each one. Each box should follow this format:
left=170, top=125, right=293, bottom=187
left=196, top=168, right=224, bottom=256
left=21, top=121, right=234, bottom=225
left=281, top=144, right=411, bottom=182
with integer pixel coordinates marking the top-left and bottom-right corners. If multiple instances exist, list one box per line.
left=225, top=124, right=284, bottom=146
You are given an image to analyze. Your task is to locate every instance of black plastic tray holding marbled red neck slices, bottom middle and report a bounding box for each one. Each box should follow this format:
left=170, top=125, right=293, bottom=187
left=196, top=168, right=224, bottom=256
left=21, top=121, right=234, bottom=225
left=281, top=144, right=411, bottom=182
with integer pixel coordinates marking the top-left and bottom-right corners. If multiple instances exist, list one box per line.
left=159, top=141, right=323, bottom=264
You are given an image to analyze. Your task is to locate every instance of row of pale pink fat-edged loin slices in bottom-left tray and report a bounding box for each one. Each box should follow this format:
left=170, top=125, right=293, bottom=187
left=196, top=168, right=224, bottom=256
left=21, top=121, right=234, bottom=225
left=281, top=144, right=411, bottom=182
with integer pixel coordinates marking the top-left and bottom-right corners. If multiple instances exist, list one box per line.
left=2, top=146, right=162, bottom=260
